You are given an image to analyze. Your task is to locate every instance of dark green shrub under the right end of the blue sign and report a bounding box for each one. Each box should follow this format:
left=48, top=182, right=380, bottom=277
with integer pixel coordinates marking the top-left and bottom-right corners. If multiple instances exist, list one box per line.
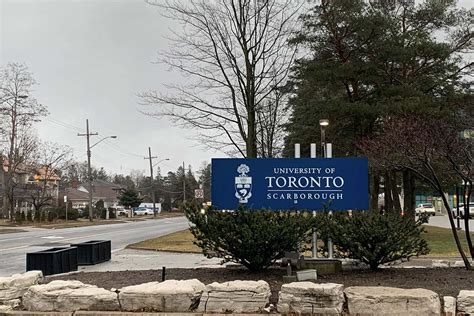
left=329, top=212, right=429, bottom=270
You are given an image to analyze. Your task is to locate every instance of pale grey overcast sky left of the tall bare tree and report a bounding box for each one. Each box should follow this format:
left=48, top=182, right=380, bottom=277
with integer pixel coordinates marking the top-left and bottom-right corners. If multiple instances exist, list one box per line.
left=0, top=0, right=474, bottom=178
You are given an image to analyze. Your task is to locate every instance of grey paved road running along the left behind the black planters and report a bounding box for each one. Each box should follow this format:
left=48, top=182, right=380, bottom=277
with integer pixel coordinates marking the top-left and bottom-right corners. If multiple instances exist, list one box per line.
left=0, top=217, right=189, bottom=276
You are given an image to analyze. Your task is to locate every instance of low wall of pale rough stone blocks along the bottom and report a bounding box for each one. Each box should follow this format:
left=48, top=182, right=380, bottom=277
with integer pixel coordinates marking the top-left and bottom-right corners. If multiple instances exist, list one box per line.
left=0, top=271, right=474, bottom=316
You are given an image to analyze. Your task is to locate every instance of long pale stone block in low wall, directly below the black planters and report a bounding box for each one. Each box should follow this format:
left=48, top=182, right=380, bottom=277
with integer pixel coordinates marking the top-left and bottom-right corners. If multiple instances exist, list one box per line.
left=23, top=280, right=120, bottom=312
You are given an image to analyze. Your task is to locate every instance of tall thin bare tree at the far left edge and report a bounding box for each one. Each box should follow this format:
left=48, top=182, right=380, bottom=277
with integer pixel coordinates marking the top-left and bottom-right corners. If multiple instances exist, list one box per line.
left=0, top=63, right=47, bottom=218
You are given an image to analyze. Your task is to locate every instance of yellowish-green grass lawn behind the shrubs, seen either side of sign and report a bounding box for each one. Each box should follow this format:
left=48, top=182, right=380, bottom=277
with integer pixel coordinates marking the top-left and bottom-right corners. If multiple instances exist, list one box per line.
left=128, top=225, right=474, bottom=257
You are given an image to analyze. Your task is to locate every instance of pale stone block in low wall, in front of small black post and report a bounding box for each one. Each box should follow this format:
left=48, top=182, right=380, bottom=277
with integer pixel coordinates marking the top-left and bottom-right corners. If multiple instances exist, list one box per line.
left=119, top=279, right=206, bottom=312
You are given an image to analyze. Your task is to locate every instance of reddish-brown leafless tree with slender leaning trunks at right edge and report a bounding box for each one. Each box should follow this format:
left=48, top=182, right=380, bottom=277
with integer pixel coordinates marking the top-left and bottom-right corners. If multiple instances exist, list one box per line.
left=360, top=116, right=474, bottom=269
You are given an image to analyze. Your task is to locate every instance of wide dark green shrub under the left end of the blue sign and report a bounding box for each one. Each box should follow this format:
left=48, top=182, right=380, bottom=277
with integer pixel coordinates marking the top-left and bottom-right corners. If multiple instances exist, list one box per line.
left=185, top=207, right=312, bottom=271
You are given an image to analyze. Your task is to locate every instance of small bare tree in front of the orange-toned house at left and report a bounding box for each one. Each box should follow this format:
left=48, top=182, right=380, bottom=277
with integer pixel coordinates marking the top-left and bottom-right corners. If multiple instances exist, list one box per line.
left=26, top=142, right=72, bottom=211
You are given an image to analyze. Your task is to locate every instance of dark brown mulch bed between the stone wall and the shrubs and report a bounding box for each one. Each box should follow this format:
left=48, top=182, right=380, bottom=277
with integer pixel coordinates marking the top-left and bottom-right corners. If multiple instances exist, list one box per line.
left=46, top=267, right=474, bottom=304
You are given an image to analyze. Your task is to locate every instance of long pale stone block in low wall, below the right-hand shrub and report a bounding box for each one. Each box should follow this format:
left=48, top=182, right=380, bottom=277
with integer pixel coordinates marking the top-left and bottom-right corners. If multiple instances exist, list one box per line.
left=344, top=286, right=441, bottom=315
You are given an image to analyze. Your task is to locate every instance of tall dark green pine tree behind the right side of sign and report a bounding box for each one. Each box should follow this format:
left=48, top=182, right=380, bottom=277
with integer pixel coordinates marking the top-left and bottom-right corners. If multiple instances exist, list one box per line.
left=285, top=0, right=473, bottom=212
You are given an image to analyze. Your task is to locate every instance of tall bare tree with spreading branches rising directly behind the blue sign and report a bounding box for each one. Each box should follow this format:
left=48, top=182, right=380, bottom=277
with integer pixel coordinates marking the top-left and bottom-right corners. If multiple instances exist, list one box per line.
left=139, top=0, right=302, bottom=157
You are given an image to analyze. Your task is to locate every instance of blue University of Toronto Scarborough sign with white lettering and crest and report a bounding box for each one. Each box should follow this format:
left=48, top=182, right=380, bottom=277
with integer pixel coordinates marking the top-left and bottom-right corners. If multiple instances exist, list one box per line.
left=212, top=158, right=369, bottom=210
